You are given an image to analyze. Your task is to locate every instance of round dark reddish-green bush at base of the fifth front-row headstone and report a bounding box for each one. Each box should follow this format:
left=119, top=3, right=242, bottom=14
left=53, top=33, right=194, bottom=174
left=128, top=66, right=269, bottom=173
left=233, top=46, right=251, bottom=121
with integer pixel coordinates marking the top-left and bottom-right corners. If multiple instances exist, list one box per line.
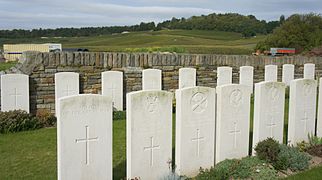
left=255, top=138, right=280, bottom=163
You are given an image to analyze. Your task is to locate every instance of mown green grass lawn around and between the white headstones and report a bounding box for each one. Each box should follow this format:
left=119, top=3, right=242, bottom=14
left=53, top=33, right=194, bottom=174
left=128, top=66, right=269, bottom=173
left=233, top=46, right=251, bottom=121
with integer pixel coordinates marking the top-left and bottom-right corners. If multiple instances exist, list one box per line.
left=0, top=95, right=322, bottom=179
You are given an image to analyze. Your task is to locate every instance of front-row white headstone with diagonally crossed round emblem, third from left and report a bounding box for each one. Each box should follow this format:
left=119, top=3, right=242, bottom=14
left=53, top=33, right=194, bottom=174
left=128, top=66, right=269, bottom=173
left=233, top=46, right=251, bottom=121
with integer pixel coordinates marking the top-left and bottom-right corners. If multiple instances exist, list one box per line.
left=175, top=87, right=216, bottom=177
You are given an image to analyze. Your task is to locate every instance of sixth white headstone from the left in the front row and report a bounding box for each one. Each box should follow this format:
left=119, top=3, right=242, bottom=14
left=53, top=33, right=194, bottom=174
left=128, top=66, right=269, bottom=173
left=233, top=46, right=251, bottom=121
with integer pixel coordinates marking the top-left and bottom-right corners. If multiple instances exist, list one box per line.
left=287, top=79, right=317, bottom=145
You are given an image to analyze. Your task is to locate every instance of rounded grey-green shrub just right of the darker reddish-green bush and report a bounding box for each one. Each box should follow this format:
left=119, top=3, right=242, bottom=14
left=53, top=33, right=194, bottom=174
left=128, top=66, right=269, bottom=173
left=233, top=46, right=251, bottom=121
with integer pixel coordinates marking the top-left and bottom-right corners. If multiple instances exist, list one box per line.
left=272, top=144, right=311, bottom=171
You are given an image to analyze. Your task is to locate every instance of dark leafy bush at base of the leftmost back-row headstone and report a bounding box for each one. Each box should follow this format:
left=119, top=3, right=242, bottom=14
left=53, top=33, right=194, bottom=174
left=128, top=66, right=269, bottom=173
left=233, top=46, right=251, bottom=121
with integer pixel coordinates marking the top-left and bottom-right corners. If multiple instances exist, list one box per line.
left=0, top=110, right=41, bottom=134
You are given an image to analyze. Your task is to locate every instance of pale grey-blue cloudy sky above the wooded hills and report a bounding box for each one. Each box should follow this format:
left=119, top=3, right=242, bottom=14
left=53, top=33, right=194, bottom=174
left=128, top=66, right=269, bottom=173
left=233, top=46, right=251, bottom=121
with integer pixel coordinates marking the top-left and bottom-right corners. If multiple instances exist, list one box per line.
left=0, top=0, right=322, bottom=29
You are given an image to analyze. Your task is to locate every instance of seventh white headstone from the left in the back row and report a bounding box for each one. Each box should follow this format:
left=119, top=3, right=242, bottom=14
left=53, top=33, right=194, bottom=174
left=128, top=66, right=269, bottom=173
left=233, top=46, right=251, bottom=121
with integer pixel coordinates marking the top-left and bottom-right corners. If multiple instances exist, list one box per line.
left=239, top=66, right=254, bottom=92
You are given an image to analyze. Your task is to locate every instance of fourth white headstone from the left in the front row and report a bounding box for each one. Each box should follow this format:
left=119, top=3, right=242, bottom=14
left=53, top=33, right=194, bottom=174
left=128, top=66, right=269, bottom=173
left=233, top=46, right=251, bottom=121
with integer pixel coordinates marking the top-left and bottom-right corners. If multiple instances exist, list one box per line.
left=215, top=84, right=251, bottom=163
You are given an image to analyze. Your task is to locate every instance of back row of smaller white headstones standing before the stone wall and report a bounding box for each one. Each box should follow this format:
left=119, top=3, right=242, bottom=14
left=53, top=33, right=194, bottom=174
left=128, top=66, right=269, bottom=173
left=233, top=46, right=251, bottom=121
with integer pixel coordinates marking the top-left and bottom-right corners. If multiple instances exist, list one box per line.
left=1, top=64, right=315, bottom=112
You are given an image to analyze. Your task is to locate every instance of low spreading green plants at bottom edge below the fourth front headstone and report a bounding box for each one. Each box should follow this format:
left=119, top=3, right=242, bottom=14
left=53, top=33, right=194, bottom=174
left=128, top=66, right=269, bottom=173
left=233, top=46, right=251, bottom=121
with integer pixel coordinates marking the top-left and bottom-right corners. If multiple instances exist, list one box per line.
left=196, top=157, right=277, bottom=180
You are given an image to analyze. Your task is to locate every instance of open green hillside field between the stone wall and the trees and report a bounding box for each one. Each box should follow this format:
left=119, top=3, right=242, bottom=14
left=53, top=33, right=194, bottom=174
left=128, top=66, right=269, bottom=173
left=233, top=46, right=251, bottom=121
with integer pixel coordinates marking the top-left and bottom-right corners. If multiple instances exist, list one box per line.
left=0, top=30, right=265, bottom=54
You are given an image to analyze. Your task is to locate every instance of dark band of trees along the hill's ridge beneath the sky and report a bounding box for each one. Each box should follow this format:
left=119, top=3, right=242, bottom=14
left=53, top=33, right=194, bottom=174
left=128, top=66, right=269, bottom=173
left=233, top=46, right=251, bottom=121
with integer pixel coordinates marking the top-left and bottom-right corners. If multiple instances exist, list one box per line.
left=0, top=13, right=280, bottom=38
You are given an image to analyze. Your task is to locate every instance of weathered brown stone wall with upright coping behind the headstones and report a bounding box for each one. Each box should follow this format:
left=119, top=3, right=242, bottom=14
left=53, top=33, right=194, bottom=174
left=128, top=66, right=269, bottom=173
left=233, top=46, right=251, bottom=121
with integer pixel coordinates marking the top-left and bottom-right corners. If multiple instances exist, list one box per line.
left=0, top=52, right=322, bottom=113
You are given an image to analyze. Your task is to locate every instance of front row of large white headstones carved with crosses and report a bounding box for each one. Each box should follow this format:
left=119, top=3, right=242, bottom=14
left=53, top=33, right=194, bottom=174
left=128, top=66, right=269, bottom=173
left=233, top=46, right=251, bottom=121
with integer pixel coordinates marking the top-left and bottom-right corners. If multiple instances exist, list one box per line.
left=57, top=64, right=322, bottom=179
